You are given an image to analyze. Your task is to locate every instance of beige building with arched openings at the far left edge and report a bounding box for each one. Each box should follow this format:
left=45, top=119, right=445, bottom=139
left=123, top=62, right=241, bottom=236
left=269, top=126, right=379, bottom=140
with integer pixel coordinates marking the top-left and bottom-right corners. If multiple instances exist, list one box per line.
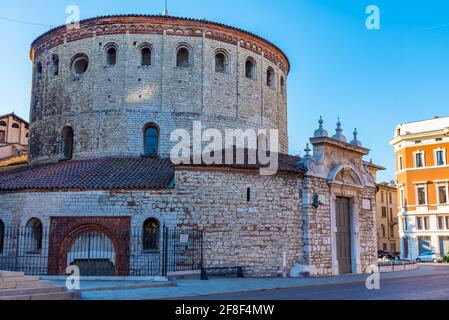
left=0, top=113, right=29, bottom=167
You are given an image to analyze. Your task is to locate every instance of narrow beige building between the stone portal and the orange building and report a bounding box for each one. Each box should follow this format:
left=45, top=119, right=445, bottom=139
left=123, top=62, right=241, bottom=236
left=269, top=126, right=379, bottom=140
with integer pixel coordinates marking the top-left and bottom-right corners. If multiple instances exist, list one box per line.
left=367, top=162, right=400, bottom=253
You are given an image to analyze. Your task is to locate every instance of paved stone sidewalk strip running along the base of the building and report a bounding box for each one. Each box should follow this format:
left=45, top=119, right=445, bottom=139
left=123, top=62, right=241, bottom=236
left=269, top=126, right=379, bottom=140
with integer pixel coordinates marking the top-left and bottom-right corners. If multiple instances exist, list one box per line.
left=58, top=265, right=449, bottom=300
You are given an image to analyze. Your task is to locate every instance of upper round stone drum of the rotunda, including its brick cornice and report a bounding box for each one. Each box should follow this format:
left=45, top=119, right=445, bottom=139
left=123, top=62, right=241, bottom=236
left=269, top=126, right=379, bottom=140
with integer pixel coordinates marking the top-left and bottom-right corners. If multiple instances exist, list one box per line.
left=30, top=16, right=290, bottom=163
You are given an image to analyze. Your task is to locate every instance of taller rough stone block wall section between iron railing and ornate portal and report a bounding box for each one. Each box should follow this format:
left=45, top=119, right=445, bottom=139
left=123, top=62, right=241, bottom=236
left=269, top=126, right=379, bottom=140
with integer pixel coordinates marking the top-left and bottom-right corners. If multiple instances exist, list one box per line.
left=173, top=171, right=303, bottom=276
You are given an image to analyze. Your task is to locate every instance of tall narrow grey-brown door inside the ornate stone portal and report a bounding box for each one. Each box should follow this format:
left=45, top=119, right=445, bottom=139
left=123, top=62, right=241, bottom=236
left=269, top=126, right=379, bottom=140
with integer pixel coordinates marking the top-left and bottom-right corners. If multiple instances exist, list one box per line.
left=336, top=197, right=352, bottom=274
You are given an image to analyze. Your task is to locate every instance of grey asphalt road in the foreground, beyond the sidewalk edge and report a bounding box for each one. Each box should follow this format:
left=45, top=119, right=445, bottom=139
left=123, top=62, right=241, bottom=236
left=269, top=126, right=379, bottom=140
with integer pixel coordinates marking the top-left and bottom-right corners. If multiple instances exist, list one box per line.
left=177, top=274, right=449, bottom=300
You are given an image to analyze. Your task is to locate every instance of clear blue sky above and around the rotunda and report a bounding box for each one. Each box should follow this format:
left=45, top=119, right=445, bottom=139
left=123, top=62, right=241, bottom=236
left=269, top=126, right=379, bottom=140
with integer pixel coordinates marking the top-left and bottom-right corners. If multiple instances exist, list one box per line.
left=0, top=0, right=449, bottom=180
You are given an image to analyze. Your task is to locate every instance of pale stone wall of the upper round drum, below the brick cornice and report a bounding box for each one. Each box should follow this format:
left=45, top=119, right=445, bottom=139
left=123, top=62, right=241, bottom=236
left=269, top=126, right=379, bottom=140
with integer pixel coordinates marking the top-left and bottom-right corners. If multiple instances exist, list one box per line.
left=30, top=20, right=288, bottom=163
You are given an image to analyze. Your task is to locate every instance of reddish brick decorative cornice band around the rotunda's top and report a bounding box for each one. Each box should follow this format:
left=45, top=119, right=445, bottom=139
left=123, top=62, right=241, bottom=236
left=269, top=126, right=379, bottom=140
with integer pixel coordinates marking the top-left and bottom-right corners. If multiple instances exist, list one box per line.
left=30, top=15, right=290, bottom=74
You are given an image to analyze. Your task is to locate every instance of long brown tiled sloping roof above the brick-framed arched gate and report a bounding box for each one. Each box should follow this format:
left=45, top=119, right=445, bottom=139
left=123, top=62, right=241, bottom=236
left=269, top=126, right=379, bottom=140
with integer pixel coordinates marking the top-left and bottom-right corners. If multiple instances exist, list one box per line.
left=0, top=158, right=174, bottom=191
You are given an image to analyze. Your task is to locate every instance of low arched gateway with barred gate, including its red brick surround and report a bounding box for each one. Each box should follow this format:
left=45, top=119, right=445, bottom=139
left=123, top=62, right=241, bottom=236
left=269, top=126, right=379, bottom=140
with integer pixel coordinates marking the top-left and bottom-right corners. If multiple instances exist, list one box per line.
left=48, top=217, right=131, bottom=276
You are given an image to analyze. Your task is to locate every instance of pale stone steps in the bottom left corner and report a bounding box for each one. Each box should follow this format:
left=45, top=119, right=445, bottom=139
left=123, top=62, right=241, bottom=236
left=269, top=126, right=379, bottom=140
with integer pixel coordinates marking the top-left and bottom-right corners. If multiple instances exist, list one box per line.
left=0, top=271, right=80, bottom=300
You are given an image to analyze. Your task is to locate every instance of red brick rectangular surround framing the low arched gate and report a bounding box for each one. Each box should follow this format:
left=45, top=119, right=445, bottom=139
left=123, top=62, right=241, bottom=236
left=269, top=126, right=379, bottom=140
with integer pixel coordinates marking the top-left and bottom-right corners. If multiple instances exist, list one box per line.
left=48, top=217, right=131, bottom=276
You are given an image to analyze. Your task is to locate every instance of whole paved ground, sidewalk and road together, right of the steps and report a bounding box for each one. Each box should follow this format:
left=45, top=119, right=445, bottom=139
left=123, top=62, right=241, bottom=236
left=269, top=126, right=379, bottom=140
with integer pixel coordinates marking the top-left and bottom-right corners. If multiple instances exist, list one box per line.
left=73, top=264, right=449, bottom=300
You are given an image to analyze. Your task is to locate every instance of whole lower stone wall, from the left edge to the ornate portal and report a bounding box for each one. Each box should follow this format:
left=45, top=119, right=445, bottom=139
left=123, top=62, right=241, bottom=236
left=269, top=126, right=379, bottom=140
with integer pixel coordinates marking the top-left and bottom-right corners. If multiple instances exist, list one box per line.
left=0, top=170, right=302, bottom=276
